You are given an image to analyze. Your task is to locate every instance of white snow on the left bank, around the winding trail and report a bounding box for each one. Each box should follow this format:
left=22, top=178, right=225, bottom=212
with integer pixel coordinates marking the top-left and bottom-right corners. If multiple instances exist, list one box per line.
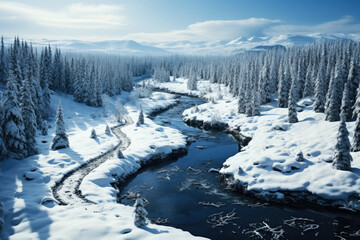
left=0, top=92, right=205, bottom=240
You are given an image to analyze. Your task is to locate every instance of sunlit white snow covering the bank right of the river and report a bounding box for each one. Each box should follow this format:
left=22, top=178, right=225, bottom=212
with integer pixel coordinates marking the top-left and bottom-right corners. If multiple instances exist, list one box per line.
left=152, top=79, right=360, bottom=202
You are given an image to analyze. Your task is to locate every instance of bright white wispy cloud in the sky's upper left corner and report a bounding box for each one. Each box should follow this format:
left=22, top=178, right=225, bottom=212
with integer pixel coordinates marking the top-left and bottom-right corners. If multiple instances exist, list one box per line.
left=0, top=2, right=125, bottom=29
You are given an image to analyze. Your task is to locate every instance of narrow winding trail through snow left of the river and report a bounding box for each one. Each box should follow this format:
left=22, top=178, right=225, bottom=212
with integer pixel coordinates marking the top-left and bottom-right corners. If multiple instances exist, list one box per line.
left=53, top=115, right=134, bottom=205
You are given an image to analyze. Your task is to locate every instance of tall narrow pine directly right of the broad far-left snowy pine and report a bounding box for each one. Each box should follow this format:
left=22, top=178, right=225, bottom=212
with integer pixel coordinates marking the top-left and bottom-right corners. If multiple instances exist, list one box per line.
left=21, top=78, right=38, bottom=156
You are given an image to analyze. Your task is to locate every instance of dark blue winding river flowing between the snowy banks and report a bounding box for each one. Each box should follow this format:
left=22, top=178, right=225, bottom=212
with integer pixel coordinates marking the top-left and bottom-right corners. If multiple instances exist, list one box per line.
left=120, top=94, right=360, bottom=240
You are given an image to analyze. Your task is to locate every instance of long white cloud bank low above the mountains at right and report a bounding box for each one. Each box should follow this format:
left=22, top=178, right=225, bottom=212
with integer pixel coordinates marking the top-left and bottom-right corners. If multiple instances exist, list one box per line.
left=125, top=16, right=360, bottom=42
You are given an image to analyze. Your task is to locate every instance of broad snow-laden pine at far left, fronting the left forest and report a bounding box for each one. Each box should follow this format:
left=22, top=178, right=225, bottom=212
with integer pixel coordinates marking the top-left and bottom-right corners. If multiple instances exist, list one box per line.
left=3, top=79, right=28, bottom=159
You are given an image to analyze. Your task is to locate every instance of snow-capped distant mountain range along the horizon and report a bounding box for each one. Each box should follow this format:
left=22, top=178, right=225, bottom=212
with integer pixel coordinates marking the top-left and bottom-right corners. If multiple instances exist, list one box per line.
left=5, top=34, right=360, bottom=56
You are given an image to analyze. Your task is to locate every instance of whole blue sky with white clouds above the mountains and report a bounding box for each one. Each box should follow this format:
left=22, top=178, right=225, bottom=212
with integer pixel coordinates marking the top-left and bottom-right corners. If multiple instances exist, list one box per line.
left=0, top=0, right=360, bottom=42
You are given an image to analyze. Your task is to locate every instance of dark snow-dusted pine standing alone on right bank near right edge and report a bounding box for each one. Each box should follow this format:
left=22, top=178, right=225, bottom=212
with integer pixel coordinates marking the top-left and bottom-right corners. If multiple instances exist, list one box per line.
left=332, top=104, right=352, bottom=171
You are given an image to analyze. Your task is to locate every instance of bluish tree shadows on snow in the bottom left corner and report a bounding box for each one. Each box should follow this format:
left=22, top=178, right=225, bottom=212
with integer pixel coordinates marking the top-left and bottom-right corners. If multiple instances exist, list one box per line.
left=0, top=156, right=52, bottom=240
